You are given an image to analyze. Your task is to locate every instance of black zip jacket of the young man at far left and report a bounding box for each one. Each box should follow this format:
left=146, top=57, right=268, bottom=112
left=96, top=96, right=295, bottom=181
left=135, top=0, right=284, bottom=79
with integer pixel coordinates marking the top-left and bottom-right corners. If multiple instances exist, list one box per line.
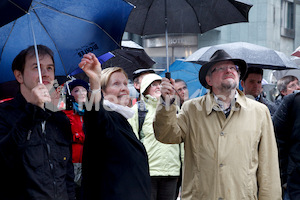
left=0, top=94, right=75, bottom=200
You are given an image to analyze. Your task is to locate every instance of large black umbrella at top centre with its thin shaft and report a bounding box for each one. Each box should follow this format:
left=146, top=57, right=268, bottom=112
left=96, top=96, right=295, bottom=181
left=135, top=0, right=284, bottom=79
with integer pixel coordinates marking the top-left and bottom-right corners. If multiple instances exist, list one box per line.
left=125, top=0, right=252, bottom=72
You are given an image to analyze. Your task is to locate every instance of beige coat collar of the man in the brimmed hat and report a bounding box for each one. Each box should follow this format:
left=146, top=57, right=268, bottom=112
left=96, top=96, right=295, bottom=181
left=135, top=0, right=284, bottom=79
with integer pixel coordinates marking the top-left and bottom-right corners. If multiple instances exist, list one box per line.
left=205, top=89, right=247, bottom=115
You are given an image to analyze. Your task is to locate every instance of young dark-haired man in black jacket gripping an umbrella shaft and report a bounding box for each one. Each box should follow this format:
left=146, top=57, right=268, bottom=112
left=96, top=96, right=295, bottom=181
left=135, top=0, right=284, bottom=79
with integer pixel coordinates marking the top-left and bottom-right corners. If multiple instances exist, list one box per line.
left=0, top=45, right=75, bottom=200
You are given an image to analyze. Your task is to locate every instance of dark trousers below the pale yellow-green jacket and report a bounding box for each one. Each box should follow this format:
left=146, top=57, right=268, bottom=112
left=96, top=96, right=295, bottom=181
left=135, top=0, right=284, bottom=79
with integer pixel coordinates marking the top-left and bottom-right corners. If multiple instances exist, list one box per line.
left=151, top=176, right=178, bottom=200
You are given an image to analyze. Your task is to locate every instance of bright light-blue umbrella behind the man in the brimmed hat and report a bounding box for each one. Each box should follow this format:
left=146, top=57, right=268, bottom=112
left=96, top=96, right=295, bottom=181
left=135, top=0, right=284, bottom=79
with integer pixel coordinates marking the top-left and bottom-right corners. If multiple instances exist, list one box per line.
left=160, top=60, right=206, bottom=98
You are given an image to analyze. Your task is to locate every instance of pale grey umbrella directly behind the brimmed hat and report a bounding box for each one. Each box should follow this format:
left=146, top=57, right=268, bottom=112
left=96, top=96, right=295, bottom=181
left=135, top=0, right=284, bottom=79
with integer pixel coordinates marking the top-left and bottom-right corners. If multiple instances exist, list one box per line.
left=185, top=42, right=298, bottom=70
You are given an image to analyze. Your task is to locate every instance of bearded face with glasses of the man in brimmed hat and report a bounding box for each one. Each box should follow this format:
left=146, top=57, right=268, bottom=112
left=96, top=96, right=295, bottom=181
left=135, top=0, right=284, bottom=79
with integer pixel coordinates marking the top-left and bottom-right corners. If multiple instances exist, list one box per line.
left=206, top=61, right=239, bottom=92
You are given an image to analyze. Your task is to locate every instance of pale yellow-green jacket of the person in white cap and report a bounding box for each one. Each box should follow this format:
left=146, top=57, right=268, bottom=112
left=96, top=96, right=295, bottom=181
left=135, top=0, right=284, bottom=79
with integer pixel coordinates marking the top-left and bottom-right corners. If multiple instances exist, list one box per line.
left=128, top=95, right=181, bottom=176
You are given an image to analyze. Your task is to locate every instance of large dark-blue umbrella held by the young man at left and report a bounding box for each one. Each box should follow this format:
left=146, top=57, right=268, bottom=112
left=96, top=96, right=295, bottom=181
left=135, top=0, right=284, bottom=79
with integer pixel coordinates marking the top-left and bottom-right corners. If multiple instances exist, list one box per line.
left=0, top=0, right=133, bottom=83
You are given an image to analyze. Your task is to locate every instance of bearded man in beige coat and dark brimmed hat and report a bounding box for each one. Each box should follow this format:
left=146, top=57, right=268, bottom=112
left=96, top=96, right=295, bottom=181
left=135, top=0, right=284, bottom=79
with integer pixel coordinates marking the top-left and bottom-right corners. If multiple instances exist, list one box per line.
left=154, top=50, right=281, bottom=200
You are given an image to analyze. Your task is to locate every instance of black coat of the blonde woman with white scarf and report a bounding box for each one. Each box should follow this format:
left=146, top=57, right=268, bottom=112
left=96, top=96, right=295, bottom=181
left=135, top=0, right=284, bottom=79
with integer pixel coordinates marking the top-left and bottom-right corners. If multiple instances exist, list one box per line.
left=82, top=103, right=151, bottom=200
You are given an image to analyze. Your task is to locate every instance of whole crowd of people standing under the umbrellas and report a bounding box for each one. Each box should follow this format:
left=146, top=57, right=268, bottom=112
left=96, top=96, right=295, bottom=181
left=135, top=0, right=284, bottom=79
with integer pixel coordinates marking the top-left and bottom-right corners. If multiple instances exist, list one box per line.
left=0, top=45, right=300, bottom=200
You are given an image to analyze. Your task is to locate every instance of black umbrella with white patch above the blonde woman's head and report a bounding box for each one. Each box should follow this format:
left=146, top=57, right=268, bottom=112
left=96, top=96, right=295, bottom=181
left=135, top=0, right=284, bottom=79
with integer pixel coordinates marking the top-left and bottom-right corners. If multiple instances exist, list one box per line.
left=102, top=41, right=155, bottom=79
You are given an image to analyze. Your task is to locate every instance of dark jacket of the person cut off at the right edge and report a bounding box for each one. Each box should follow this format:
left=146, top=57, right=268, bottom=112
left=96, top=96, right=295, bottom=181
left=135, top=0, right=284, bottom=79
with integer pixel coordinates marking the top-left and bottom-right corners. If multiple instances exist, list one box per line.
left=273, top=93, right=300, bottom=200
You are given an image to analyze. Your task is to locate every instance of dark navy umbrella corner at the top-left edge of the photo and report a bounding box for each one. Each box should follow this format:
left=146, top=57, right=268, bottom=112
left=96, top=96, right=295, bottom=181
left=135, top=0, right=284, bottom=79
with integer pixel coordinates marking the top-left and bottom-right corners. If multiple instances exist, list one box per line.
left=0, top=0, right=32, bottom=27
